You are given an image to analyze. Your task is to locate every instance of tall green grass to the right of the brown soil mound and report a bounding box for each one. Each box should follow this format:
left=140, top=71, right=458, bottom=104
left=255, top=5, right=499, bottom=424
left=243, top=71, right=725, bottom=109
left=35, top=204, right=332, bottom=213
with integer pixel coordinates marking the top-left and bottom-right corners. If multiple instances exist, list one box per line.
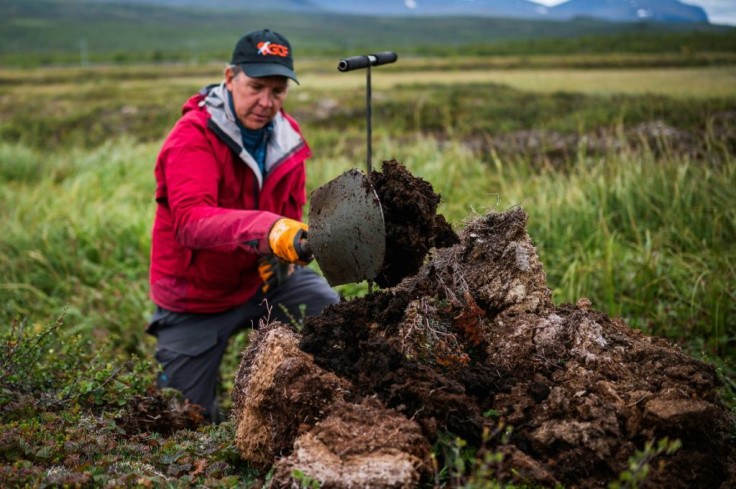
left=503, top=142, right=736, bottom=356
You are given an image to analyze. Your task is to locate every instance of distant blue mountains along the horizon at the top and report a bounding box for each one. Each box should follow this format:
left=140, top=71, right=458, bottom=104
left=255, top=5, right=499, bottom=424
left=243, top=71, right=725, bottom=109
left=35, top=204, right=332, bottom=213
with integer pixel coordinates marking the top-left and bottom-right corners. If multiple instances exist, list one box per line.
left=83, top=0, right=708, bottom=23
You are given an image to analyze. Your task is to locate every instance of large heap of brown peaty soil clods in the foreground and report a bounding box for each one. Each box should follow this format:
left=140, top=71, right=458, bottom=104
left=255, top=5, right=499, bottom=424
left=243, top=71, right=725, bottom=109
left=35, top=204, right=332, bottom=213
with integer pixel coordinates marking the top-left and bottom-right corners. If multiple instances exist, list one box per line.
left=233, top=163, right=736, bottom=488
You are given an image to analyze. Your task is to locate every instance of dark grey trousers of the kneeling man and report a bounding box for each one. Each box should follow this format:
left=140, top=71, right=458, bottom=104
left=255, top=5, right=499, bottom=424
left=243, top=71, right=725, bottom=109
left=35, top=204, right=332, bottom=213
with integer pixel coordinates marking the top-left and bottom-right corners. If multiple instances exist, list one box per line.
left=147, top=266, right=340, bottom=423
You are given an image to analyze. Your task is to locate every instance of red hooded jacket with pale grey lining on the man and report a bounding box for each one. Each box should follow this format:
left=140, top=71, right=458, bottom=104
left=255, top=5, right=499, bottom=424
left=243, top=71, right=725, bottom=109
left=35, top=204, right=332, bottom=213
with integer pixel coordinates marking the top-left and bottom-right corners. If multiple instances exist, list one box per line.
left=150, top=84, right=312, bottom=313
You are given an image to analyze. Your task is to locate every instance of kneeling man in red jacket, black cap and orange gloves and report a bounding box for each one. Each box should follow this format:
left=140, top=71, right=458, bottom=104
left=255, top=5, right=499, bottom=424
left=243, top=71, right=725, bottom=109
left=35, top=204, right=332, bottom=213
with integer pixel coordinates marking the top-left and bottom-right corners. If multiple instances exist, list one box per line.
left=148, top=30, right=339, bottom=422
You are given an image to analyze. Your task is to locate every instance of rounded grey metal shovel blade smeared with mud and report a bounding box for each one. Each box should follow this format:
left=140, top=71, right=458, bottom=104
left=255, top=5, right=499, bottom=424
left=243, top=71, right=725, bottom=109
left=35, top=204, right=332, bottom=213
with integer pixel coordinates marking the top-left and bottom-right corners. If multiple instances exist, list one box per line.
left=309, top=169, right=386, bottom=286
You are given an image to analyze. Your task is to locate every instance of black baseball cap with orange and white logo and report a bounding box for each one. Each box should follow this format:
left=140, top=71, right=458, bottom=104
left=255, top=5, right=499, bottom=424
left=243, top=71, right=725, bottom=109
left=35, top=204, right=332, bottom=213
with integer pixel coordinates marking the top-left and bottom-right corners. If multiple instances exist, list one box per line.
left=230, top=29, right=299, bottom=83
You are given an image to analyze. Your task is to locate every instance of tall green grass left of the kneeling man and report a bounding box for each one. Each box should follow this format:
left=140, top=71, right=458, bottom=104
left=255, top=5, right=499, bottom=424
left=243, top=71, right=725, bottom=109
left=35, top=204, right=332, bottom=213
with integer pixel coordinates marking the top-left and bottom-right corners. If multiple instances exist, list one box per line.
left=0, top=140, right=155, bottom=354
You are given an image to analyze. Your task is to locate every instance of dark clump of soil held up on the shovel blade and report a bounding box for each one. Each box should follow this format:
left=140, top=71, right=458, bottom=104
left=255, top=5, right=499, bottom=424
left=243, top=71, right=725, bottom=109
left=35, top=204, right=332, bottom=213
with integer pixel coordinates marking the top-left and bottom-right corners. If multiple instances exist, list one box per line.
left=371, top=160, right=458, bottom=287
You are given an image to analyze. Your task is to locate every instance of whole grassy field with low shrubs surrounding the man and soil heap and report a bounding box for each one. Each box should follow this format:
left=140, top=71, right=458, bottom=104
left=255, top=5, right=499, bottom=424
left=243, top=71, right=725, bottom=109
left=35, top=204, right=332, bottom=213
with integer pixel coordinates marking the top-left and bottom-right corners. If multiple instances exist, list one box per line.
left=0, top=57, right=736, bottom=487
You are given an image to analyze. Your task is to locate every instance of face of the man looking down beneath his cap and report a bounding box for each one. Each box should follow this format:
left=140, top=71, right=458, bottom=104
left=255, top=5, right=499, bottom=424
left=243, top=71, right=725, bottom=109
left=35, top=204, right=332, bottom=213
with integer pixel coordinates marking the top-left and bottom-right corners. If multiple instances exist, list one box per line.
left=225, top=68, right=289, bottom=130
